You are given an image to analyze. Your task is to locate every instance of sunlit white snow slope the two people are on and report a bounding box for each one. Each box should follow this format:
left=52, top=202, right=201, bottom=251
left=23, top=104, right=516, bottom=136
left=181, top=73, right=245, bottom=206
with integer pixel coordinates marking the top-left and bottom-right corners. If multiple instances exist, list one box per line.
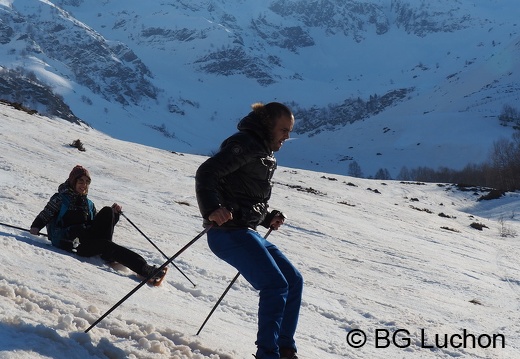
left=0, top=105, right=520, bottom=359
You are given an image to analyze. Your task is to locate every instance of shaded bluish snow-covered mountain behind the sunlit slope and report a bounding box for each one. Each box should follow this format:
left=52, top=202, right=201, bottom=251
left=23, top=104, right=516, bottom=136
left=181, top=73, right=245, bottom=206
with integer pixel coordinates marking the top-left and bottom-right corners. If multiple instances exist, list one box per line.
left=0, top=0, right=520, bottom=176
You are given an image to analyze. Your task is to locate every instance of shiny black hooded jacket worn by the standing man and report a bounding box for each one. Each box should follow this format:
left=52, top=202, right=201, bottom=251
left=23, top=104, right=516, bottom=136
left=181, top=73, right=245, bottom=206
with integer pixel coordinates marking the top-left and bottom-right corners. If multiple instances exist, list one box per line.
left=195, top=112, right=280, bottom=229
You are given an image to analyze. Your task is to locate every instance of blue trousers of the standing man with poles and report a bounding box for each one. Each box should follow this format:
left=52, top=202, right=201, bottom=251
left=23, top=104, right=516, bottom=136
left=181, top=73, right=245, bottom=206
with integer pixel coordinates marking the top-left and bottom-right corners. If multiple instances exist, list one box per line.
left=207, top=228, right=303, bottom=359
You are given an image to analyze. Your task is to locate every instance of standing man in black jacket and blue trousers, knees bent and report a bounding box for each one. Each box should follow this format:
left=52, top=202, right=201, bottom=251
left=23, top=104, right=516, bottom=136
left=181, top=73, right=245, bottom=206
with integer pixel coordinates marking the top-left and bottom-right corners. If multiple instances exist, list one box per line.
left=195, top=102, right=303, bottom=359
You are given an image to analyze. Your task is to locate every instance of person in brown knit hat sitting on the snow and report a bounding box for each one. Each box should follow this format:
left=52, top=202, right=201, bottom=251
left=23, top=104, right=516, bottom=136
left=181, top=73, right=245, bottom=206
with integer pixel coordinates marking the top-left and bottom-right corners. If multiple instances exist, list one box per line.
left=30, top=165, right=166, bottom=285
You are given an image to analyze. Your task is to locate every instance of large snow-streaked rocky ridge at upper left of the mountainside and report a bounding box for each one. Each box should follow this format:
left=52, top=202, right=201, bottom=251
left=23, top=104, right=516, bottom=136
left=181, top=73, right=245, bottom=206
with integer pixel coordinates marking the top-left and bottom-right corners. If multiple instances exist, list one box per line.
left=0, top=1, right=158, bottom=114
